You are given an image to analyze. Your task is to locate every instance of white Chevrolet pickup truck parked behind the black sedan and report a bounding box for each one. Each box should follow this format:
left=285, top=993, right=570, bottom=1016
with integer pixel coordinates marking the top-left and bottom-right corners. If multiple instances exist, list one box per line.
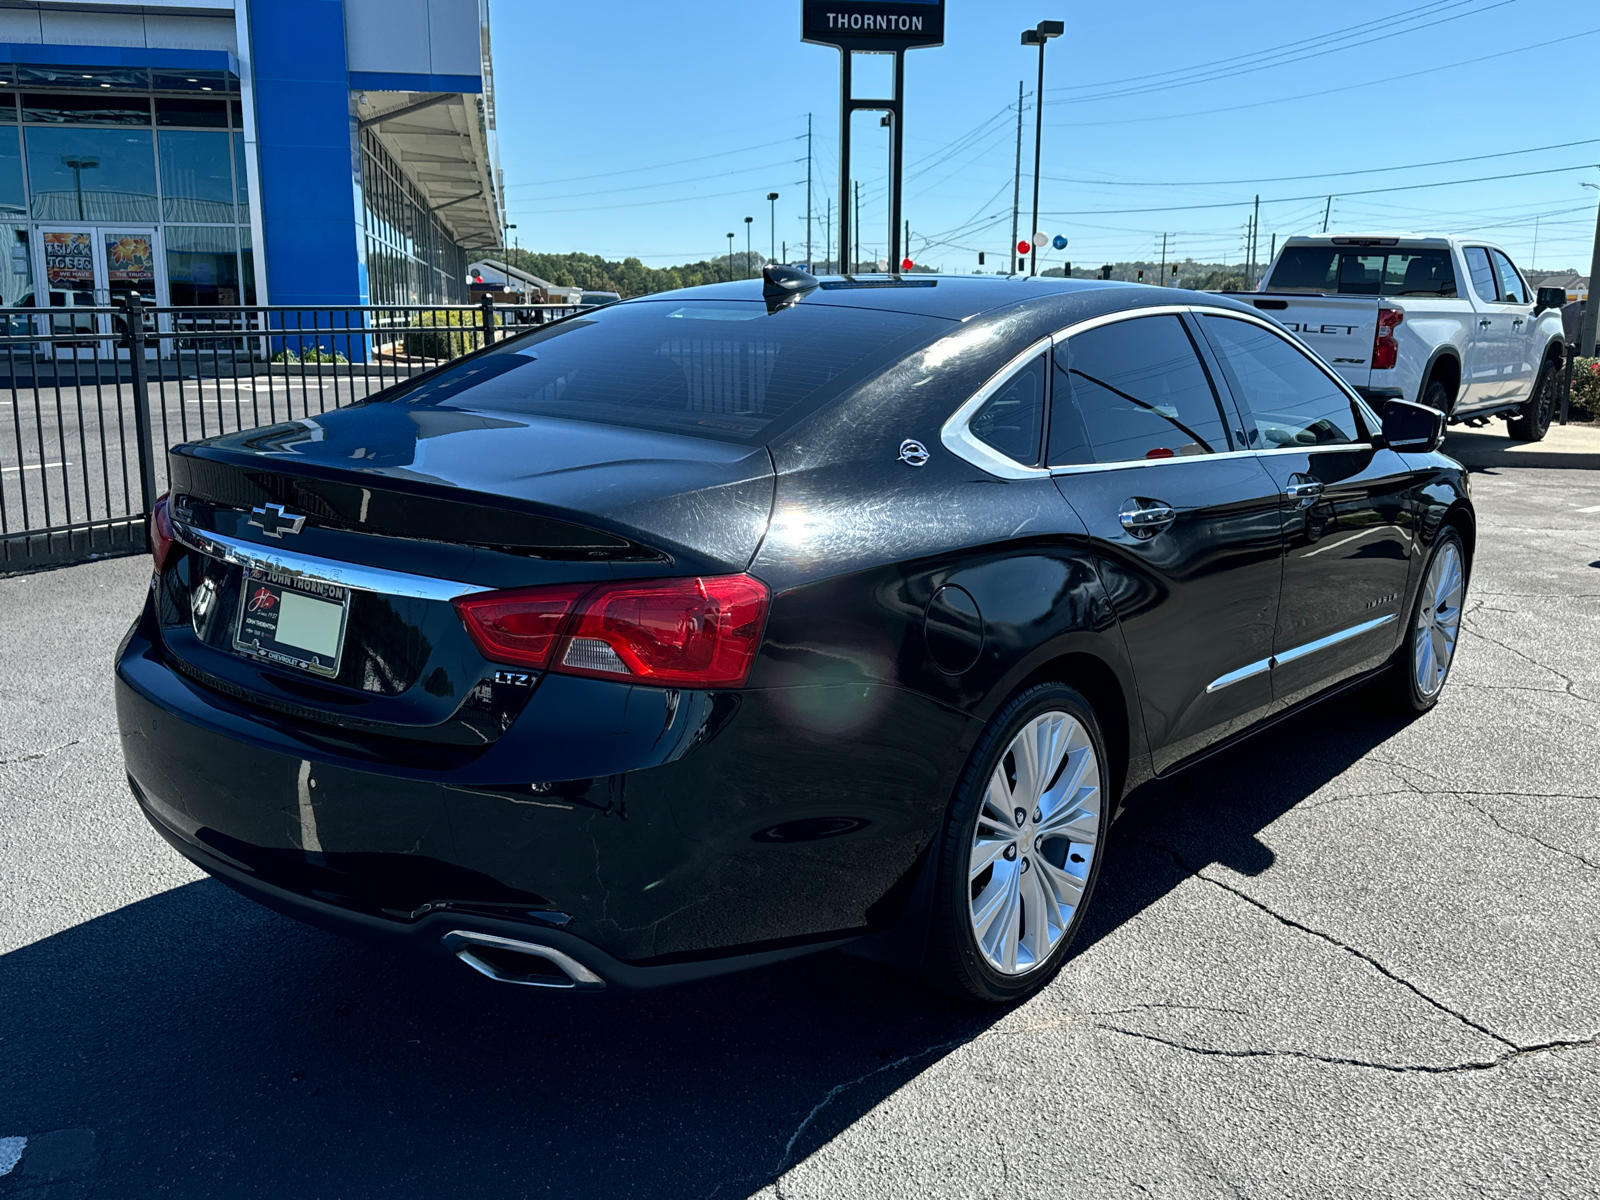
left=1240, top=234, right=1566, bottom=442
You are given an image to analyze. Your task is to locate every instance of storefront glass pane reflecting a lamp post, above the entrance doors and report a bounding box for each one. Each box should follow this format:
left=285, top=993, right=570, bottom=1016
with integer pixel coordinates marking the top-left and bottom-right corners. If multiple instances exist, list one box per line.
left=24, top=126, right=156, bottom=221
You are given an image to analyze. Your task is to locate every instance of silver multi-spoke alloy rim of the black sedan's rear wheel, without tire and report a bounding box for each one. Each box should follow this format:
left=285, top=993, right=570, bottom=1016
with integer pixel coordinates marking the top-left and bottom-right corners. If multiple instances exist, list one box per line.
left=968, top=710, right=1102, bottom=976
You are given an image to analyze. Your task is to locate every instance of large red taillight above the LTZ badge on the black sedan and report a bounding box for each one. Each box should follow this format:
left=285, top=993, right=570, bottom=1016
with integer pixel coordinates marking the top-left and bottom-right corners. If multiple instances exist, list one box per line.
left=456, top=574, right=768, bottom=688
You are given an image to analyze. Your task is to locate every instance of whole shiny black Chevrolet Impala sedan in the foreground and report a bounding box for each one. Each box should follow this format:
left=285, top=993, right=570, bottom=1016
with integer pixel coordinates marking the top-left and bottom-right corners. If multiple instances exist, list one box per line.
left=117, top=269, right=1475, bottom=1002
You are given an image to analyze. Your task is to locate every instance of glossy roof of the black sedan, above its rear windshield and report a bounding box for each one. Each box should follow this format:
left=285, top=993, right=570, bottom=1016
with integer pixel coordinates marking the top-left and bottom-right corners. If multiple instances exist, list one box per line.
left=624, top=275, right=1139, bottom=320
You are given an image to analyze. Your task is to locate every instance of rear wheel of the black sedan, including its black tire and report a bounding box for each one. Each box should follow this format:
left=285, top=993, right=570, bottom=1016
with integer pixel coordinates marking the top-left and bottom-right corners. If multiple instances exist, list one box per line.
left=926, top=682, right=1112, bottom=1003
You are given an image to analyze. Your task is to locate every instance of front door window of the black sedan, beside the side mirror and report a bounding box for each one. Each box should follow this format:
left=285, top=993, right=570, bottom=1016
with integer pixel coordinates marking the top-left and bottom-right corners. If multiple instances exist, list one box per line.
left=1202, top=315, right=1362, bottom=450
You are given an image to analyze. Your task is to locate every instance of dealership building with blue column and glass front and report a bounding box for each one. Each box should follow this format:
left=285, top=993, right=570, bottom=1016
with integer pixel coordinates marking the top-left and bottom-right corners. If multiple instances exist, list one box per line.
left=0, top=0, right=506, bottom=315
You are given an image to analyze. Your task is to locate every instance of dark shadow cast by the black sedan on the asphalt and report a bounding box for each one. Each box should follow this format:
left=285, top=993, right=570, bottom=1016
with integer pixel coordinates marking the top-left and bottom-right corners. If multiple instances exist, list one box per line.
left=0, top=694, right=1402, bottom=1200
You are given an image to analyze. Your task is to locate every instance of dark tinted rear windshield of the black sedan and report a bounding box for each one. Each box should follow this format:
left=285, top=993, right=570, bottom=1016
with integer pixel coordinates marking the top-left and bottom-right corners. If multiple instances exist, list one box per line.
left=374, top=301, right=955, bottom=443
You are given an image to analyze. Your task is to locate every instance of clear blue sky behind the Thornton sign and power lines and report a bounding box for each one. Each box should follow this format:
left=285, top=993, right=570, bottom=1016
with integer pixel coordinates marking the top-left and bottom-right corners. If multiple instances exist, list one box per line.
left=491, top=0, right=1600, bottom=272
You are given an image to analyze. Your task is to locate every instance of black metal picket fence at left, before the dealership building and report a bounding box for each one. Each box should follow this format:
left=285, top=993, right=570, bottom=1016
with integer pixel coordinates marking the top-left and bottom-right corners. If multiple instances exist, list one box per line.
left=0, top=296, right=576, bottom=574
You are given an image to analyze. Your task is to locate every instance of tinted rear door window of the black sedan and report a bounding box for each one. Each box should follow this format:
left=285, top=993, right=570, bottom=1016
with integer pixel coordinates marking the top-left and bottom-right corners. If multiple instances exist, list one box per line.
left=1050, top=315, right=1229, bottom=467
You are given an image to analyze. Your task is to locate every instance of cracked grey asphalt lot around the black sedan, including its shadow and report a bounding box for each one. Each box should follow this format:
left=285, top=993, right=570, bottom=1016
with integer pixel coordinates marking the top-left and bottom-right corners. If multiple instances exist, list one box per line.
left=0, top=424, right=1600, bottom=1200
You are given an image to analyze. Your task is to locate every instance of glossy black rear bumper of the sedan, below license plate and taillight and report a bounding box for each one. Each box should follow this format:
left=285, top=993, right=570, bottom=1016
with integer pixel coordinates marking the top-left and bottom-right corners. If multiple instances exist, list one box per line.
left=115, top=608, right=957, bottom=987
